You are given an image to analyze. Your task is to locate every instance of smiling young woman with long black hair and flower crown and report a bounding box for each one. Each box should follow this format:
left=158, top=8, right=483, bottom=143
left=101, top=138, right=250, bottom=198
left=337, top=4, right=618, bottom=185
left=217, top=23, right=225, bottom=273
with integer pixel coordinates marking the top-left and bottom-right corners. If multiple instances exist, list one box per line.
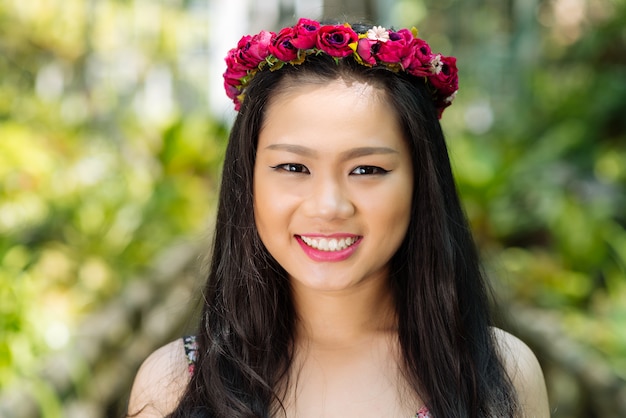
left=129, top=19, right=549, bottom=418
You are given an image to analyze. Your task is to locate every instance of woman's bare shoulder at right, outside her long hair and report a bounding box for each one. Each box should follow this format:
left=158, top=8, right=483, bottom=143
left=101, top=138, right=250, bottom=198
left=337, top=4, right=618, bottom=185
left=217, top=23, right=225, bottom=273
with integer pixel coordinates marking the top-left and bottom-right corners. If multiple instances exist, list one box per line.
left=494, top=328, right=550, bottom=418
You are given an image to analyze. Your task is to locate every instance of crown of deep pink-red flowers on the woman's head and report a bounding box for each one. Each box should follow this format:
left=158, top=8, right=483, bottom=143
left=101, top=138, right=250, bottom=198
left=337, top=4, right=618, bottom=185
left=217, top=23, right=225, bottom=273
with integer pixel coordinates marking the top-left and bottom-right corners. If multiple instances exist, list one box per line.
left=224, top=19, right=459, bottom=118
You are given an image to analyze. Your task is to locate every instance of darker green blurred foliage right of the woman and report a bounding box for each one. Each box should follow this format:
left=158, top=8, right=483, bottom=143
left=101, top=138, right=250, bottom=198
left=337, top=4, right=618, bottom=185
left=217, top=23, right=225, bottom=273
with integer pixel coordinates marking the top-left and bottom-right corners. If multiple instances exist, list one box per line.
left=428, top=0, right=626, bottom=378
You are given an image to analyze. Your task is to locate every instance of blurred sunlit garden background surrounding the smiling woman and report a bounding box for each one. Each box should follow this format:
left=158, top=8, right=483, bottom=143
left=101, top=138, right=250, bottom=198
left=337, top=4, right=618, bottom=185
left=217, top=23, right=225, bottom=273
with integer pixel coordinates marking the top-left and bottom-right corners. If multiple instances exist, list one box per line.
left=0, top=0, right=626, bottom=418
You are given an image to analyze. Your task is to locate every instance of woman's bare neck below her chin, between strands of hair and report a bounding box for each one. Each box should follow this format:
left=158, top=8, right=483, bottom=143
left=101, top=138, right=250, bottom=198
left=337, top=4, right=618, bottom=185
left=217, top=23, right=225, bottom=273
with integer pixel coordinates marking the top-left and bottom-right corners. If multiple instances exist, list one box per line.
left=293, top=274, right=396, bottom=348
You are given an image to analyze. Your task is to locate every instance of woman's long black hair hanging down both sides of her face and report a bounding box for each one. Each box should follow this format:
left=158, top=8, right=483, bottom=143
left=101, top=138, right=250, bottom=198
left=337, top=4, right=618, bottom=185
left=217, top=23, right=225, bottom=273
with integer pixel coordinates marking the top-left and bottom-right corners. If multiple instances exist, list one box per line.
left=170, top=40, right=517, bottom=418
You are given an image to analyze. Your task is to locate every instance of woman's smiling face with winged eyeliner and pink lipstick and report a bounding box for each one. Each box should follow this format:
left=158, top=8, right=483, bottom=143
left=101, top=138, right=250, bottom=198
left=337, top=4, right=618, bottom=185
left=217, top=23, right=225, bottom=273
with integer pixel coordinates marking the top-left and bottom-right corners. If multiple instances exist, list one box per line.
left=254, top=80, right=413, bottom=291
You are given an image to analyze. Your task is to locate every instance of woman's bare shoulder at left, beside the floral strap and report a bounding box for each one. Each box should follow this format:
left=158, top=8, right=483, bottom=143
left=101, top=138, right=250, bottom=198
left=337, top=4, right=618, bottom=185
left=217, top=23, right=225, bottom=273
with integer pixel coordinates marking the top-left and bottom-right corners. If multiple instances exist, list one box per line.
left=128, top=339, right=189, bottom=418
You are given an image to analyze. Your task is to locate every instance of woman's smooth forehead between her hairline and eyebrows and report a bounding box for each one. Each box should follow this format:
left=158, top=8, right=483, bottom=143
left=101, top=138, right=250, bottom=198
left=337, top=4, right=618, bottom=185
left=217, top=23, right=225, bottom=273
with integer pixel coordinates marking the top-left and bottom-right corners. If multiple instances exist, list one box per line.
left=259, top=79, right=404, bottom=148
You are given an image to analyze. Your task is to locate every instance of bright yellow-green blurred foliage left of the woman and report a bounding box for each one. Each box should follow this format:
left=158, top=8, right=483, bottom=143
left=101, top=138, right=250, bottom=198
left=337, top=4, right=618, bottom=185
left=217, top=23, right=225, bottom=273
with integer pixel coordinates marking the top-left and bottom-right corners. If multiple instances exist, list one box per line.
left=0, top=0, right=226, bottom=402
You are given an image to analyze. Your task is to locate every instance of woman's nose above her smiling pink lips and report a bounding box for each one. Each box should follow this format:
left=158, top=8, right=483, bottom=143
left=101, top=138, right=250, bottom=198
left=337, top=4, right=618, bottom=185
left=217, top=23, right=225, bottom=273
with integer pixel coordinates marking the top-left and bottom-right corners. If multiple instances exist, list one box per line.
left=304, top=176, right=355, bottom=221
